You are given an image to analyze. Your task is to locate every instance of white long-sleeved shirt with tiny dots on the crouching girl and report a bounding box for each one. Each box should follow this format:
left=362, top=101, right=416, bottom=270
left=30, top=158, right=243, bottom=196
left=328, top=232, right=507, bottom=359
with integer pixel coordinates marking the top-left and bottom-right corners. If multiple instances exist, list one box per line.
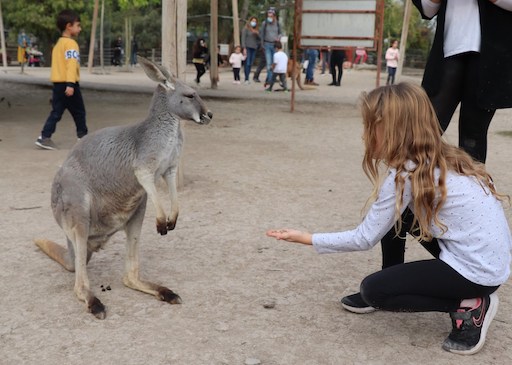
left=313, top=164, right=512, bottom=286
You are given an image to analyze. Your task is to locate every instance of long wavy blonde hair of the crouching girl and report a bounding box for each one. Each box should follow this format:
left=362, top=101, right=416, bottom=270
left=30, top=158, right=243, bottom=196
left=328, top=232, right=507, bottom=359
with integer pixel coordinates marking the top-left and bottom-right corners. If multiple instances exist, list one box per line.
left=361, top=83, right=508, bottom=241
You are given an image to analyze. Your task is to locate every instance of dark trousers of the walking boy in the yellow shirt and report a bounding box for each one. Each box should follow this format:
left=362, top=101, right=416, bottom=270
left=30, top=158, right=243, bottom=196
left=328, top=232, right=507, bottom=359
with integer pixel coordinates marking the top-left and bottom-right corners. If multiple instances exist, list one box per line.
left=41, top=82, right=87, bottom=138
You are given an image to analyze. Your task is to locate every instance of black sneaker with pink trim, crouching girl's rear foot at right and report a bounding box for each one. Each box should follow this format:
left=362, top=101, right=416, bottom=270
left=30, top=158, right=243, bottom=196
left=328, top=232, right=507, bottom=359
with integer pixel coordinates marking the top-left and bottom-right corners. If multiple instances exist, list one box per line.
left=443, top=293, right=499, bottom=355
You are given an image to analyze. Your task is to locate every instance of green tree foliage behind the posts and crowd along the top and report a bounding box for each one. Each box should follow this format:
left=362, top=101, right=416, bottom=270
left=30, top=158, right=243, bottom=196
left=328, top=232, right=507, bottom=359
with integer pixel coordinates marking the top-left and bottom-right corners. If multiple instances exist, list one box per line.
left=2, top=0, right=435, bottom=67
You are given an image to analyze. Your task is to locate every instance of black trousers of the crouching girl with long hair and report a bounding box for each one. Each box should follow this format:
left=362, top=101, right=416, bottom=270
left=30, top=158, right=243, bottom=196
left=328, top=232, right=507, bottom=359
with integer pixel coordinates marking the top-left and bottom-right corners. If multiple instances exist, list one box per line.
left=360, top=209, right=498, bottom=312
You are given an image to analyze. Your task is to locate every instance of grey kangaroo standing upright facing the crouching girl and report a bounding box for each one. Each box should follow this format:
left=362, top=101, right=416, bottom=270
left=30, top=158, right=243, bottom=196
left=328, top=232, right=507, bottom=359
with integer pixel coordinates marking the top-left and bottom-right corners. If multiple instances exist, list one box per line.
left=35, top=56, right=213, bottom=319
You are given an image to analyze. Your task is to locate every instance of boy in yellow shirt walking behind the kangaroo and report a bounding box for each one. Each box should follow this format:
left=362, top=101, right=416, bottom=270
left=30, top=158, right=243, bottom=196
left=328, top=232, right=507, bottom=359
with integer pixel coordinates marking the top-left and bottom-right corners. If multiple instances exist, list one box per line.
left=36, top=10, right=87, bottom=150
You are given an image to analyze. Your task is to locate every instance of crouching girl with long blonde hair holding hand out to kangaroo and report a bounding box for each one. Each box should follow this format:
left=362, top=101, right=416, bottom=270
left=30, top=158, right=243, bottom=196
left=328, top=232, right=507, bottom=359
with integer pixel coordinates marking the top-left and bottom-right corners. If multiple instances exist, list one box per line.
left=267, top=83, right=511, bottom=355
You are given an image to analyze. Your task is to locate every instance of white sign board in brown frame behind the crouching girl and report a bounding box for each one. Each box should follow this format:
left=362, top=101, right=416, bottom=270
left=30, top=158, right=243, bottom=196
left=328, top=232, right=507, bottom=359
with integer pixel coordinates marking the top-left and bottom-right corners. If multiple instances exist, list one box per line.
left=300, top=0, right=377, bottom=49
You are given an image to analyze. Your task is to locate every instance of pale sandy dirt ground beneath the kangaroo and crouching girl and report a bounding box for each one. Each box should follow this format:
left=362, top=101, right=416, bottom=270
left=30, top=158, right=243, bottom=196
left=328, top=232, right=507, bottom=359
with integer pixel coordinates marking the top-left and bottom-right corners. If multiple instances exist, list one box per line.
left=0, top=66, right=512, bottom=365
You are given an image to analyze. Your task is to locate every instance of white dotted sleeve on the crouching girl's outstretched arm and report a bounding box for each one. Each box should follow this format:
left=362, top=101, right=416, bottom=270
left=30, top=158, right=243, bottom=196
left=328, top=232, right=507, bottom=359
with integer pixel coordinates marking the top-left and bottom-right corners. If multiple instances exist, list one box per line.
left=312, top=172, right=411, bottom=253
